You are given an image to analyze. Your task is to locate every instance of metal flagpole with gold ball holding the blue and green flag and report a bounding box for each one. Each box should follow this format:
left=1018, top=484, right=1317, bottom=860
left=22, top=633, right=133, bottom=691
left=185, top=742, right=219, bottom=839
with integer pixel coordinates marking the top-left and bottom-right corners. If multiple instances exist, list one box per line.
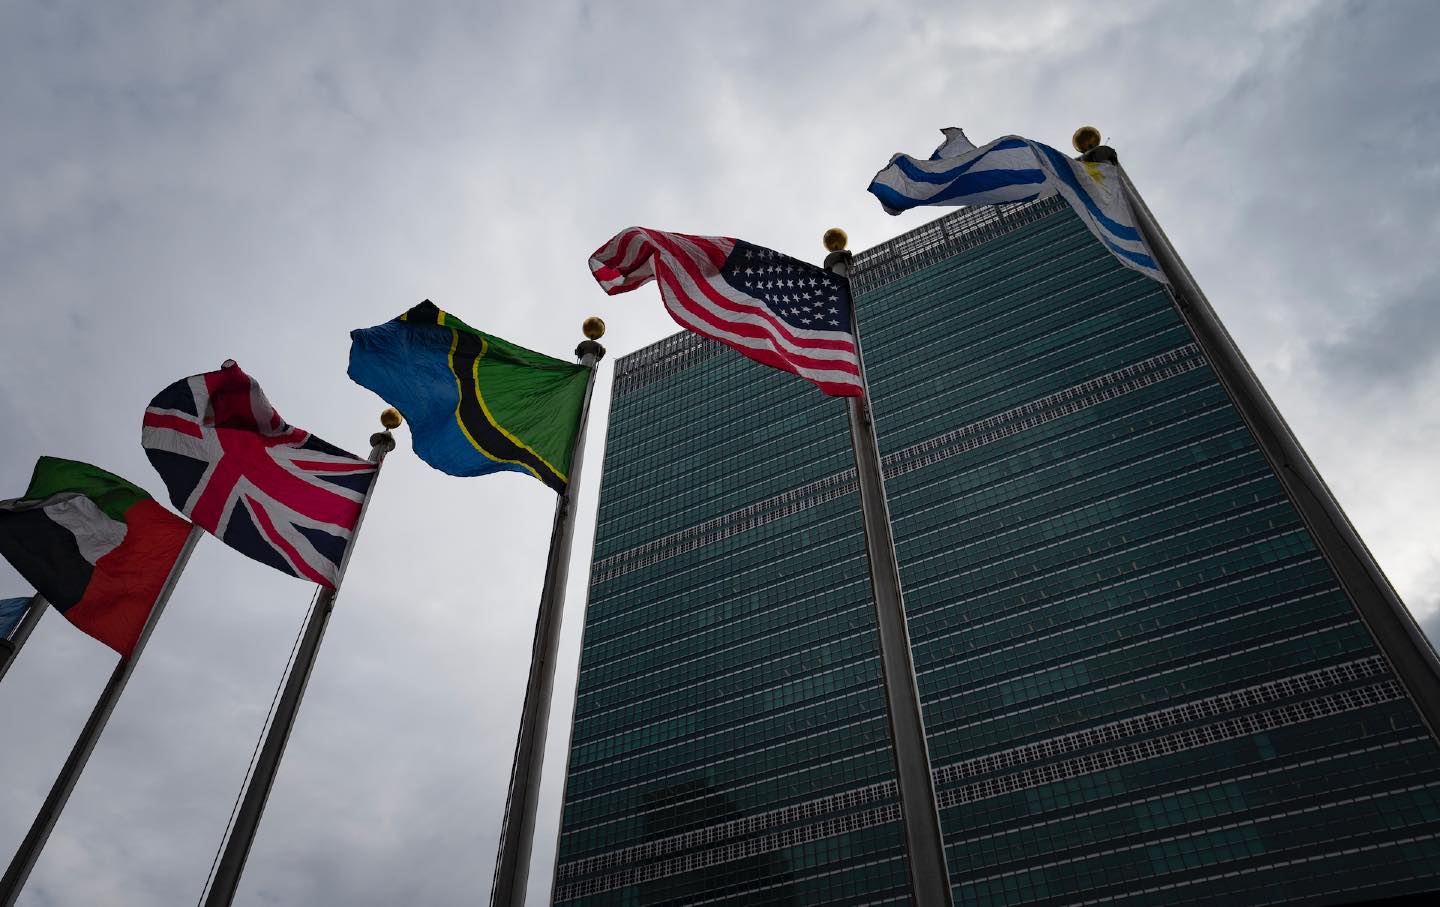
left=490, top=317, right=605, bottom=907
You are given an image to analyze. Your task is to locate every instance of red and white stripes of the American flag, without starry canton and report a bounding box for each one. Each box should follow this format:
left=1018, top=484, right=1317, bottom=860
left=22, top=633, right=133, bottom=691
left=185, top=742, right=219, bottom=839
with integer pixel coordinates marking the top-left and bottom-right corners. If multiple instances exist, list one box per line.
left=590, top=227, right=863, bottom=397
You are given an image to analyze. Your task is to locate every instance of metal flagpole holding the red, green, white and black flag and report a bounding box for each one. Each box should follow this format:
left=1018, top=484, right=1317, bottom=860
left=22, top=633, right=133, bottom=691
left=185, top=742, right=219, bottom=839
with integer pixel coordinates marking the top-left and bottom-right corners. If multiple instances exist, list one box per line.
left=0, top=525, right=203, bottom=907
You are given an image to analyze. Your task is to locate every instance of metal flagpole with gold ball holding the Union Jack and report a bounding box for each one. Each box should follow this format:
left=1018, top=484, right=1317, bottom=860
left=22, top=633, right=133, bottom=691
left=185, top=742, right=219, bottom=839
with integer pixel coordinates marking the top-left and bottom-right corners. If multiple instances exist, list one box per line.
left=203, top=409, right=400, bottom=907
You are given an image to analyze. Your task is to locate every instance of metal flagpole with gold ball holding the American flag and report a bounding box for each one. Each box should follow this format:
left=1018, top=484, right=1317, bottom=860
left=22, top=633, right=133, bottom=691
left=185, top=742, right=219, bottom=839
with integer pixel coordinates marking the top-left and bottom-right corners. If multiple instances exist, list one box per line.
left=825, top=229, right=952, bottom=907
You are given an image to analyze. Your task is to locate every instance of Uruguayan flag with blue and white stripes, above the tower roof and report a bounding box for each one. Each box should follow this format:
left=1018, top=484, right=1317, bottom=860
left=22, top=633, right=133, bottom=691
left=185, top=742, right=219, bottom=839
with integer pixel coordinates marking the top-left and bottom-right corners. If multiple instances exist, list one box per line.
left=870, top=127, right=1168, bottom=284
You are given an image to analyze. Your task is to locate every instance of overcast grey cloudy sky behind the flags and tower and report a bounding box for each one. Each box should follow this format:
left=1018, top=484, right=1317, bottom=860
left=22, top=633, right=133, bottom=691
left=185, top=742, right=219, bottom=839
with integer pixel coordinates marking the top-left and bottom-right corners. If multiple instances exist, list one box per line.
left=0, top=0, right=1440, bottom=907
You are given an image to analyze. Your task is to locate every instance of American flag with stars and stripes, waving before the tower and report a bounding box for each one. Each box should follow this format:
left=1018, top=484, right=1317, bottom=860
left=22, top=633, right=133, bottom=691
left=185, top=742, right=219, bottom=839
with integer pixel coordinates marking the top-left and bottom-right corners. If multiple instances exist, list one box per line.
left=590, top=227, right=863, bottom=397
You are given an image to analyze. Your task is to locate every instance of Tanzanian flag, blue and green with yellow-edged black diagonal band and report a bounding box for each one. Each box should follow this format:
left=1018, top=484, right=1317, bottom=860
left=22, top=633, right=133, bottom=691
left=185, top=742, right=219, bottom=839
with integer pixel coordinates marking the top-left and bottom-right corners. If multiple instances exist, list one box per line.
left=348, top=299, right=589, bottom=494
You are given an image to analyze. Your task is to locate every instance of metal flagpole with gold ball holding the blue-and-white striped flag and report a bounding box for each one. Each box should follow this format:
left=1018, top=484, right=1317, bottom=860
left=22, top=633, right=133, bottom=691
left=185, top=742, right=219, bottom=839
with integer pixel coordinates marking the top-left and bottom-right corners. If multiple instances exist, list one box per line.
left=1094, top=127, right=1440, bottom=740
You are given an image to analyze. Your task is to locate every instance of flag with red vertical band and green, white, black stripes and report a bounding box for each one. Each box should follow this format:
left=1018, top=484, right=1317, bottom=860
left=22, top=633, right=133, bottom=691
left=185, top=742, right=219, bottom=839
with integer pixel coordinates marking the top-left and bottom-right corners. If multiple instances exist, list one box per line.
left=0, top=456, right=190, bottom=658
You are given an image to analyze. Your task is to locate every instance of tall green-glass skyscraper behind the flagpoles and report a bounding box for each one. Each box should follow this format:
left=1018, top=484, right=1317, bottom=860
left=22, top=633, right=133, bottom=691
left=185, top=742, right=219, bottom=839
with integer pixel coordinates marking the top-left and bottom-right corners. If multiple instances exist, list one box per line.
left=554, top=200, right=1440, bottom=906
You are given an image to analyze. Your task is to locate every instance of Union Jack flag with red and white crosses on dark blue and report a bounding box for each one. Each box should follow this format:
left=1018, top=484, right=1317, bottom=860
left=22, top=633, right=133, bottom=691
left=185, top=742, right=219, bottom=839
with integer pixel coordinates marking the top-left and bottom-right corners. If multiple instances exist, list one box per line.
left=140, top=360, right=376, bottom=587
